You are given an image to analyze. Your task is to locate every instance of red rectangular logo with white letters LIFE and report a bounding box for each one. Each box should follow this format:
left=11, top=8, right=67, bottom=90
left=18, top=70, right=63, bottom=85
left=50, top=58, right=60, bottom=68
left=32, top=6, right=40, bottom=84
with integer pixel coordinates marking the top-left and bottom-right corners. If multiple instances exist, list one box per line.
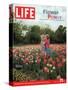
left=15, top=6, right=35, bottom=19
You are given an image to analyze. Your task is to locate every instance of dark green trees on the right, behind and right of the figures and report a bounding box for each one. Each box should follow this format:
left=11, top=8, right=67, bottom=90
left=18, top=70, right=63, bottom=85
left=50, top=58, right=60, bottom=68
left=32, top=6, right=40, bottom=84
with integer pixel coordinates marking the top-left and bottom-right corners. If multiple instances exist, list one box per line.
left=41, top=25, right=66, bottom=43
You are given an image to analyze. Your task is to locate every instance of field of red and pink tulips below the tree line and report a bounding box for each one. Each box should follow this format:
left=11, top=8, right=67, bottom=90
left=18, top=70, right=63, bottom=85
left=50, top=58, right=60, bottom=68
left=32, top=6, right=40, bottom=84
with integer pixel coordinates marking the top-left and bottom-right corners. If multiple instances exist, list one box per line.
left=10, top=44, right=66, bottom=81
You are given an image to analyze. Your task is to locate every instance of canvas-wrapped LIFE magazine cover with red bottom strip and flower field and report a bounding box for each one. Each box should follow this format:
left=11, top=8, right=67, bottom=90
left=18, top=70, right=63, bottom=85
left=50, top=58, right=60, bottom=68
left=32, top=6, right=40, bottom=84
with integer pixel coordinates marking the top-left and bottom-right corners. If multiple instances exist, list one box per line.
left=9, top=4, right=66, bottom=86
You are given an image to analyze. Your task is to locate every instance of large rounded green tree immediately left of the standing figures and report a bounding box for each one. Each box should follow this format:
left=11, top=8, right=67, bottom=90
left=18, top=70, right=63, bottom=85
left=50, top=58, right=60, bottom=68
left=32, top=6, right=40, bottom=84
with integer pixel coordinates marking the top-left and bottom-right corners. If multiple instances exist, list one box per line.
left=23, top=26, right=41, bottom=44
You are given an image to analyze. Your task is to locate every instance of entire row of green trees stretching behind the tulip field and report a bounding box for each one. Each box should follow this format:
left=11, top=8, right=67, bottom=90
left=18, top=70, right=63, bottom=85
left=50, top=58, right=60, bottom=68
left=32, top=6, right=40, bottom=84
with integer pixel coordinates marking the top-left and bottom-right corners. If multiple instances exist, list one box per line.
left=9, top=22, right=66, bottom=44
